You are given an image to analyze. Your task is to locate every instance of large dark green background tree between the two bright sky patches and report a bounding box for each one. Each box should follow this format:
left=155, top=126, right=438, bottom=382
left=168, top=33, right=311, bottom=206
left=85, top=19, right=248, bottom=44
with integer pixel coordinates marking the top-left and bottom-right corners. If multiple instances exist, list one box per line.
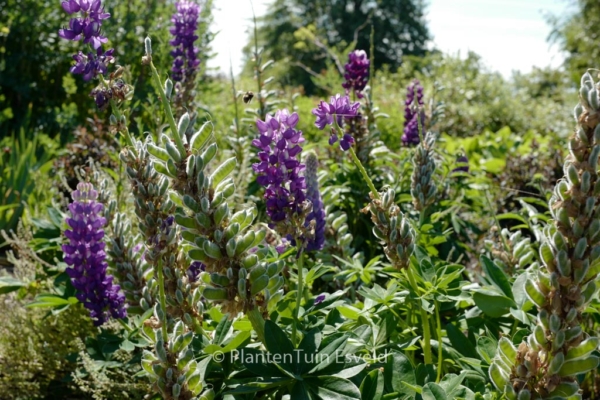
left=246, top=0, right=430, bottom=94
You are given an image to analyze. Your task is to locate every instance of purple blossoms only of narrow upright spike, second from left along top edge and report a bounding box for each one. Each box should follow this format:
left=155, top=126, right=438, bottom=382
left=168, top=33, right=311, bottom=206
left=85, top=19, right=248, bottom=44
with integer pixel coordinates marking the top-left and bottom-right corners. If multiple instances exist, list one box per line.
left=169, top=0, right=200, bottom=82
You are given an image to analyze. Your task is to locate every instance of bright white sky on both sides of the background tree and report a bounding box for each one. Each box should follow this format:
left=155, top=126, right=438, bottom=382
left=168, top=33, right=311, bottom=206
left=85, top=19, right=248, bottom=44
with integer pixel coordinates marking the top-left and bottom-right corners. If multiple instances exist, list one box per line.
left=209, top=0, right=571, bottom=77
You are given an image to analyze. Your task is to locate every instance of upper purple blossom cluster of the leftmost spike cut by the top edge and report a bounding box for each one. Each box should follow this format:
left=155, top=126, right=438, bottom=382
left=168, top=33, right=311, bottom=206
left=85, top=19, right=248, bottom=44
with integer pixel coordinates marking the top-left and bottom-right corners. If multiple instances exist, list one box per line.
left=58, top=0, right=110, bottom=50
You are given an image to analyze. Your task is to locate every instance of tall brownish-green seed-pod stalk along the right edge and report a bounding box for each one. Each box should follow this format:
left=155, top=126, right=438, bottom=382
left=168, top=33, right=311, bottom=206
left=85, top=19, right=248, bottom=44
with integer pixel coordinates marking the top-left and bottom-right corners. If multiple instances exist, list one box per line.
left=490, top=73, right=600, bottom=399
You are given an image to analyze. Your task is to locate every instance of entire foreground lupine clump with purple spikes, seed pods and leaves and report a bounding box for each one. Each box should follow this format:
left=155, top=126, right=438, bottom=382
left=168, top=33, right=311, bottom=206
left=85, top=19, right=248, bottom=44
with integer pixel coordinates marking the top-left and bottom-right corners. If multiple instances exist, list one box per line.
left=0, top=0, right=600, bottom=400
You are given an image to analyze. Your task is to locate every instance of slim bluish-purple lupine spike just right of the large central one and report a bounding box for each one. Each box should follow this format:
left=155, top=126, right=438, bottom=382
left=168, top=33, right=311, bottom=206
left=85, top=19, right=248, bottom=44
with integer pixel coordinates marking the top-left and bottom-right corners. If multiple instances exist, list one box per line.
left=304, top=152, right=325, bottom=251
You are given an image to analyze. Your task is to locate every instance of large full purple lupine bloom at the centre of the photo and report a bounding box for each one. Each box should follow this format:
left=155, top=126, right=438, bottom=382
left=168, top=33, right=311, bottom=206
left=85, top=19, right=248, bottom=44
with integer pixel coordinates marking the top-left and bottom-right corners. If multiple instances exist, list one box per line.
left=252, top=109, right=306, bottom=223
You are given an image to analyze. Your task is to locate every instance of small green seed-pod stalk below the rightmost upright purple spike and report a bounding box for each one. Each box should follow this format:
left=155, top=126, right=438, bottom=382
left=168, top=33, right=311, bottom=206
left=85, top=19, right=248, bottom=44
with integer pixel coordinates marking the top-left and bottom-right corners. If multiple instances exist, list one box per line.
left=410, top=132, right=437, bottom=213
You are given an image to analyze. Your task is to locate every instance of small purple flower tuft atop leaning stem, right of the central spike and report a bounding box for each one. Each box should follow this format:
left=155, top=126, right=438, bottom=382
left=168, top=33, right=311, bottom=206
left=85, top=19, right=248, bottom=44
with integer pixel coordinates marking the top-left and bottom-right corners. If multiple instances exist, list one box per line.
left=312, top=94, right=360, bottom=151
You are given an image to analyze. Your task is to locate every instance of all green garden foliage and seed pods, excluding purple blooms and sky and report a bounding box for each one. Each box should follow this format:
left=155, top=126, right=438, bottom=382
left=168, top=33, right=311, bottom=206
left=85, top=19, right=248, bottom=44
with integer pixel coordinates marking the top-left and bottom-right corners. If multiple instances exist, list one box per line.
left=0, top=0, right=600, bottom=400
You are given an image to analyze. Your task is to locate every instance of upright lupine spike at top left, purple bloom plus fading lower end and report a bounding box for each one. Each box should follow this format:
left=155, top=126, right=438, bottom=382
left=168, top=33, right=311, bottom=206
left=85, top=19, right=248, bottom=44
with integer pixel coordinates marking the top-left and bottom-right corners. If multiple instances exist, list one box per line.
left=169, top=0, right=200, bottom=116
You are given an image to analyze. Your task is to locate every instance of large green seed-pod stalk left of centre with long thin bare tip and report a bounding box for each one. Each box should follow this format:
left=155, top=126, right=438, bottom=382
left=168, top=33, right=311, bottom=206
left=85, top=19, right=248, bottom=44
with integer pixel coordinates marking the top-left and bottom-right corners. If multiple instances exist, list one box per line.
left=145, top=38, right=283, bottom=343
